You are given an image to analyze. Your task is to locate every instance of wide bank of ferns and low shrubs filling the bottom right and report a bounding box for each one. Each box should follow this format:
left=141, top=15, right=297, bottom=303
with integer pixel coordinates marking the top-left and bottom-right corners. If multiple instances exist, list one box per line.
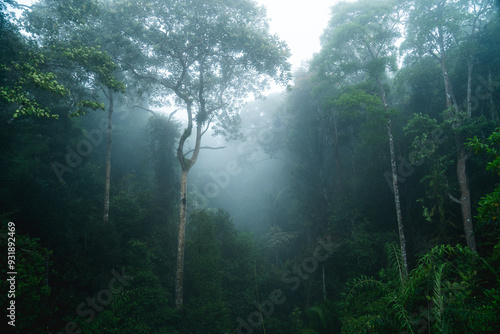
left=343, top=245, right=498, bottom=333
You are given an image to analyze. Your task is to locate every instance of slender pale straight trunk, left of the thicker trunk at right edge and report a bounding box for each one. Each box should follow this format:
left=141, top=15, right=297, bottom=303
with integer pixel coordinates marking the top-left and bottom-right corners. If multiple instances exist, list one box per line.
left=376, top=76, right=408, bottom=277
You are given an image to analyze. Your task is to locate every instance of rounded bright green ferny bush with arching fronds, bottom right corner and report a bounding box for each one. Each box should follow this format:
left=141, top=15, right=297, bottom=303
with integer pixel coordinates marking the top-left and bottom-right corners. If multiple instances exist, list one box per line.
left=405, top=245, right=498, bottom=333
